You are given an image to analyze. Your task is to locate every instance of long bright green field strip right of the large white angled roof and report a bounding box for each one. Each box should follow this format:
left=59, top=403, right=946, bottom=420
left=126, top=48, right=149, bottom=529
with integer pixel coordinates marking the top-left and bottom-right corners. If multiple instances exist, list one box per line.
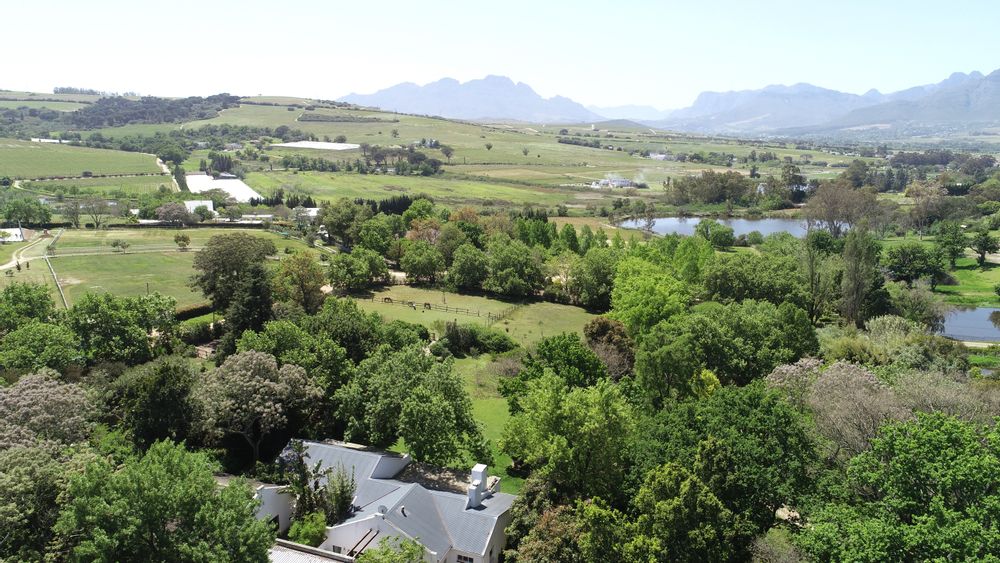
left=246, top=172, right=575, bottom=209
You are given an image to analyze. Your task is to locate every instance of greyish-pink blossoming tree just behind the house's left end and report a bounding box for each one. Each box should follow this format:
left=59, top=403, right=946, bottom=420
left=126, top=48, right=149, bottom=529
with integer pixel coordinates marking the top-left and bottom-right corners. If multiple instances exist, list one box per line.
left=194, top=352, right=320, bottom=466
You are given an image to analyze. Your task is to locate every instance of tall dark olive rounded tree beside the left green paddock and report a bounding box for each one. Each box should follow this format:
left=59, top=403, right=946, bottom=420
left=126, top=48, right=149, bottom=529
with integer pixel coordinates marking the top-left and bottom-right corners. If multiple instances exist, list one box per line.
left=191, top=233, right=277, bottom=311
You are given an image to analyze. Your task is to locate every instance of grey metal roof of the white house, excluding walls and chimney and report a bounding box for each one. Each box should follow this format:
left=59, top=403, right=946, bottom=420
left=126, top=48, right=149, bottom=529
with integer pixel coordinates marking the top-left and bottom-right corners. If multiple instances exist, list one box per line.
left=303, top=442, right=517, bottom=555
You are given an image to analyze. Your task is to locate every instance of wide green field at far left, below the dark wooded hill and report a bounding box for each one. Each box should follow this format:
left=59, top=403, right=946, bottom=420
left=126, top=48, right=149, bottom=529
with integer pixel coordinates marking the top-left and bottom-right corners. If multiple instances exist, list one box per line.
left=0, top=139, right=161, bottom=179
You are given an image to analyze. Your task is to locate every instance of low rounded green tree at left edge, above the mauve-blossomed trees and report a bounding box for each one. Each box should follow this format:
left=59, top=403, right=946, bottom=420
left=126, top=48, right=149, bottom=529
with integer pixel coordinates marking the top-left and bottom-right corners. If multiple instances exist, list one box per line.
left=0, top=321, right=85, bottom=372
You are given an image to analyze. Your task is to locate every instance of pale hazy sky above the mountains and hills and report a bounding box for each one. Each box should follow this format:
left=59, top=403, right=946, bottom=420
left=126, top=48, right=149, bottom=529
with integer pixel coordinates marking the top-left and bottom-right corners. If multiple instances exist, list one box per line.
left=7, top=0, right=1000, bottom=108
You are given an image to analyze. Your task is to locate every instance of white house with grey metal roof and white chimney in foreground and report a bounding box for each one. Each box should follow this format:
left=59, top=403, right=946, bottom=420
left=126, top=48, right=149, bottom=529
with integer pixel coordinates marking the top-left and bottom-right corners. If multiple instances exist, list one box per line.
left=266, top=441, right=516, bottom=563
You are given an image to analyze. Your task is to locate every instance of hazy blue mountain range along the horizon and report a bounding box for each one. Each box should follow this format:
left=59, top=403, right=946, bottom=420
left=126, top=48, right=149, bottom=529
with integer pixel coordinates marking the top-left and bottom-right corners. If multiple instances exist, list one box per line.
left=341, top=70, right=1000, bottom=136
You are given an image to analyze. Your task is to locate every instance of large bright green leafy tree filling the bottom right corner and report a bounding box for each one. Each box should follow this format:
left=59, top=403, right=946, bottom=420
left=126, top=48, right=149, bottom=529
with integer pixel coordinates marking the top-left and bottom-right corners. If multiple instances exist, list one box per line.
left=796, top=413, right=1000, bottom=561
